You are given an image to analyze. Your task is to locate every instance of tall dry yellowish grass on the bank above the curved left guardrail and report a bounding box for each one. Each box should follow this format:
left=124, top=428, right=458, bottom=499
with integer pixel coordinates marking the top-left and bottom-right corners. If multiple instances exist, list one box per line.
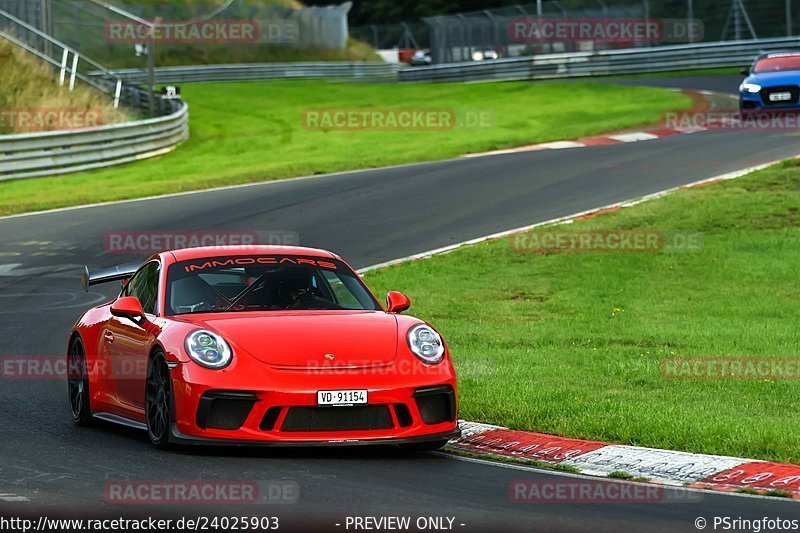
left=0, top=39, right=130, bottom=133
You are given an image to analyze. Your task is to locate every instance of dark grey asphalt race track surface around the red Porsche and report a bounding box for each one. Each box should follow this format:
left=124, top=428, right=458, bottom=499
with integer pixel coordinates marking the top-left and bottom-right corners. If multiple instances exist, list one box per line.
left=0, top=76, right=800, bottom=531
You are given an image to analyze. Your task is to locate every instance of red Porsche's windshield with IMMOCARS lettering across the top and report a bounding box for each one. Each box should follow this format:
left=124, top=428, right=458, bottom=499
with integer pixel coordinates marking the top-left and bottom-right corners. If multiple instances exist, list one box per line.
left=166, top=256, right=380, bottom=315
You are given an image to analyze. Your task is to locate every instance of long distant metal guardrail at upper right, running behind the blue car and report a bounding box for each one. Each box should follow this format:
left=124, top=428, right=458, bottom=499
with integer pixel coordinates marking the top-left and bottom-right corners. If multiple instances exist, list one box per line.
left=398, top=37, right=800, bottom=81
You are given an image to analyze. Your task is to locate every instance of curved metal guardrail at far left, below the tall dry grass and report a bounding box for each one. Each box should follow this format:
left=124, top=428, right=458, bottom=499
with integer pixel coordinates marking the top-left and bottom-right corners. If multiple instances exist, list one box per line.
left=0, top=102, right=189, bottom=181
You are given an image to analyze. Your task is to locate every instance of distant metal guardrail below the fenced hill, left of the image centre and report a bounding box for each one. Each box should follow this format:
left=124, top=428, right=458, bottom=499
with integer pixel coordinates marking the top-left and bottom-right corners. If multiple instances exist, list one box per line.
left=89, top=61, right=398, bottom=84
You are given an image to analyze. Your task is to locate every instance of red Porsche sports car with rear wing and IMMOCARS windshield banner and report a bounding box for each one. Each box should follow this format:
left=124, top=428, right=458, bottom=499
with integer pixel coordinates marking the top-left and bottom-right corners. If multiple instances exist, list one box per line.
left=68, top=246, right=459, bottom=450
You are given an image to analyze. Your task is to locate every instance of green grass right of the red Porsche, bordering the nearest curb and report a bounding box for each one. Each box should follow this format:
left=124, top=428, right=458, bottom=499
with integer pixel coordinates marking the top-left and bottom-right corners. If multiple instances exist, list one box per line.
left=367, top=161, right=800, bottom=463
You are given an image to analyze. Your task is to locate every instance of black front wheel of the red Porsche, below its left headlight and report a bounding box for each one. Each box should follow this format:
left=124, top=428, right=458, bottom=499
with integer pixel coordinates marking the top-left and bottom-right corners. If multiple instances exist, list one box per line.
left=144, top=352, right=175, bottom=450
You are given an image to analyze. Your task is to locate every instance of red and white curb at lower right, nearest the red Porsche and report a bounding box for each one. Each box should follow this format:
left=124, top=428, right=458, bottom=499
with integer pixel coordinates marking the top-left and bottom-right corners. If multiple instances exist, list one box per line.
left=448, top=420, right=800, bottom=499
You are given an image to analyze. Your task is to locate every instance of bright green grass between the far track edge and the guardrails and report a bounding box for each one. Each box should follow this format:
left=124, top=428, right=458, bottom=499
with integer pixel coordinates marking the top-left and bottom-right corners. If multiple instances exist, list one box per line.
left=0, top=81, right=691, bottom=214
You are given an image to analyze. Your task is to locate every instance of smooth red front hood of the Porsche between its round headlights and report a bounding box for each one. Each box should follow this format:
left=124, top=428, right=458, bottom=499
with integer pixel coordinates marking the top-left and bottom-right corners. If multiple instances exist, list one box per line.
left=187, top=311, right=398, bottom=368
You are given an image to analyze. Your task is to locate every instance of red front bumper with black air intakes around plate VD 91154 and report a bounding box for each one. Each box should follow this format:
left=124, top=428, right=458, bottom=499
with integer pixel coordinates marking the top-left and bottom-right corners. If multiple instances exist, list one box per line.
left=171, top=359, right=459, bottom=446
